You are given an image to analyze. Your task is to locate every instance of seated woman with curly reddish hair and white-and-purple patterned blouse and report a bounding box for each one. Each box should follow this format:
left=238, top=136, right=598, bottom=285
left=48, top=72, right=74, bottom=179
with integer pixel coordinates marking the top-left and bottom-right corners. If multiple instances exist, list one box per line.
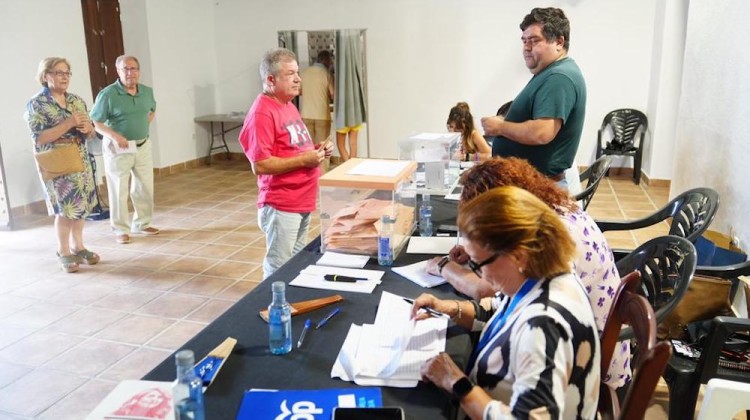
left=427, top=158, right=631, bottom=389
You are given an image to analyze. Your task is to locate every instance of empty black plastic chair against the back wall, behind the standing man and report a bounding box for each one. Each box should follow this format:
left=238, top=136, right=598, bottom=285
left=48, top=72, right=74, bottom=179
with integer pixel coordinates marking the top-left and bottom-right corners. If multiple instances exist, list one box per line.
left=596, top=108, right=648, bottom=184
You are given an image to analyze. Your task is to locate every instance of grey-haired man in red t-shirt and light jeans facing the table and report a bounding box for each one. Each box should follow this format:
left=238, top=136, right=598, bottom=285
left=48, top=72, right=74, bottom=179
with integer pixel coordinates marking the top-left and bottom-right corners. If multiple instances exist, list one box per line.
left=239, top=48, right=333, bottom=279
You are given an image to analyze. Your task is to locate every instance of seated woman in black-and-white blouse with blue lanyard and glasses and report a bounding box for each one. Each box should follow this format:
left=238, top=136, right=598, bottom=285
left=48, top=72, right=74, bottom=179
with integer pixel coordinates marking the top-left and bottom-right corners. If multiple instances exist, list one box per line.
left=412, top=187, right=600, bottom=419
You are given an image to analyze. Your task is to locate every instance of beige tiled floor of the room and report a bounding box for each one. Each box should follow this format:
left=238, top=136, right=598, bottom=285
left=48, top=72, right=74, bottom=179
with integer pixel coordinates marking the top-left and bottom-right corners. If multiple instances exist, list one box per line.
left=0, top=161, right=668, bottom=420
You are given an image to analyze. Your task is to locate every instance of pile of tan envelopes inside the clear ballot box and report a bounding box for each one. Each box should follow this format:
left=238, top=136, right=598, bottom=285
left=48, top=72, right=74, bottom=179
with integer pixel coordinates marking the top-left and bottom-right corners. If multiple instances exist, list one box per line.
left=323, top=198, right=414, bottom=255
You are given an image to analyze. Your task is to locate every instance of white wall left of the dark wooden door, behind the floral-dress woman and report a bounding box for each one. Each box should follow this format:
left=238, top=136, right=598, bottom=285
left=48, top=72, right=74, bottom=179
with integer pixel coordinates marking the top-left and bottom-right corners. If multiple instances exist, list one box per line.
left=0, top=0, right=92, bottom=207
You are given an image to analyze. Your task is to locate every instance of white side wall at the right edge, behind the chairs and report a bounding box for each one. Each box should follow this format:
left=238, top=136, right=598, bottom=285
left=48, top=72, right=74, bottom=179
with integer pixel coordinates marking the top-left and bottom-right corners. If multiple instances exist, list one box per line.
left=672, top=0, right=750, bottom=250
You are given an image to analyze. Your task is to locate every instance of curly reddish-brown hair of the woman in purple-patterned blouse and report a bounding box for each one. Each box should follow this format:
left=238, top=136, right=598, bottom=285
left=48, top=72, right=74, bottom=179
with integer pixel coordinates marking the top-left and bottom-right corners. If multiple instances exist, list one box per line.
left=461, top=157, right=578, bottom=211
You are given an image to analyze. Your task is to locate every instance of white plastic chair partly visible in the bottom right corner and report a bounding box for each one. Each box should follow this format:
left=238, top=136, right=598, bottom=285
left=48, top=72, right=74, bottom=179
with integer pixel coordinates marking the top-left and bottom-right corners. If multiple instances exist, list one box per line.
left=698, top=378, right=750, bottom=420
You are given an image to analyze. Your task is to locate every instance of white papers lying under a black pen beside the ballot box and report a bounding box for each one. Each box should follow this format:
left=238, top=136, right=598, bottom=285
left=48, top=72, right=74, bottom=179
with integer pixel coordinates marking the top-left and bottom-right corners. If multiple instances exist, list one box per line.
left=289, top=265, right=385, bottom=293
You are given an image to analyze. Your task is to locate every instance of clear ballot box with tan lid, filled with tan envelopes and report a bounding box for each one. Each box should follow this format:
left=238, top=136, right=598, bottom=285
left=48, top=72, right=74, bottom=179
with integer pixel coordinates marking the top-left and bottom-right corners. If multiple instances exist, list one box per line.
left=318, top=159, right=417, bottom=257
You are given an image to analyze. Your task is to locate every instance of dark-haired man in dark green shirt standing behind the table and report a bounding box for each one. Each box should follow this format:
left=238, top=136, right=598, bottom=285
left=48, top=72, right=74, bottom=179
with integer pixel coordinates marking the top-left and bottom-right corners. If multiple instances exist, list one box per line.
left=482, top=7, right=586, bottom=189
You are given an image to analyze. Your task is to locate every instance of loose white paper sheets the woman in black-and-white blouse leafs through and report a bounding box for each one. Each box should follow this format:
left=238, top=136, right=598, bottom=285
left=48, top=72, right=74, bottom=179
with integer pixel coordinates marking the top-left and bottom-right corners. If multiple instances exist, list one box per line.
left=331, top=292, right=448, bottom=388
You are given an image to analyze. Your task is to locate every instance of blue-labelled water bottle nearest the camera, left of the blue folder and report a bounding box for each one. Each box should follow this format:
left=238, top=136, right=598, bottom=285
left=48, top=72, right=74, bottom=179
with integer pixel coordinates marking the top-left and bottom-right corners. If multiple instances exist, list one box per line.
left=172, top=350, right=206, bottom=420
